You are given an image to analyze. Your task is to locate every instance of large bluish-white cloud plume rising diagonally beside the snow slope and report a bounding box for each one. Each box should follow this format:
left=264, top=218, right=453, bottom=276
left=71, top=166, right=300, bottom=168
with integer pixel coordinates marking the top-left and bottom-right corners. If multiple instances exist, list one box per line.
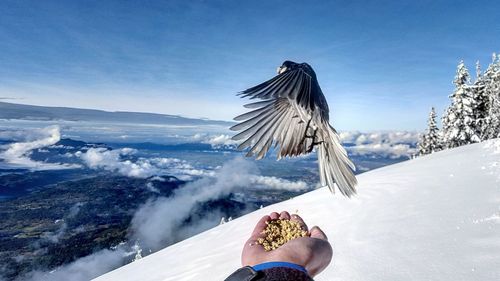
left=131, top=158, right=307, bottom=250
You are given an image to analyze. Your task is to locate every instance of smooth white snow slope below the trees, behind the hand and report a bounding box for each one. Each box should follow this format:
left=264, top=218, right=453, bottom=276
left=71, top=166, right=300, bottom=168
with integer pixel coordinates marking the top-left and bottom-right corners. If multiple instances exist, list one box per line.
left=96, top=139, right=500, bottom=281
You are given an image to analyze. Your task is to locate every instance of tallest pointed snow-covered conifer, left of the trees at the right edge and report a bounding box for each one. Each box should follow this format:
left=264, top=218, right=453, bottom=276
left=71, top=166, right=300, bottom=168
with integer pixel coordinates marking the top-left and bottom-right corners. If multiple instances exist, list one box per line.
left=443, top=61, right=481, bottom=148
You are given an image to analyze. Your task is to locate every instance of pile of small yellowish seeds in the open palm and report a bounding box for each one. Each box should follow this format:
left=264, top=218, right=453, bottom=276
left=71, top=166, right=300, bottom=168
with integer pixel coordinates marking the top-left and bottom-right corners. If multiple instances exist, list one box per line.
left=257, top=219, right=308, bottom=251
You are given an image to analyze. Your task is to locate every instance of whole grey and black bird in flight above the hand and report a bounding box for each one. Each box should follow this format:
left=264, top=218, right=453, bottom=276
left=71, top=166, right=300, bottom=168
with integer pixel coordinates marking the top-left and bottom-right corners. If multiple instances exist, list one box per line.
left=231, top=61, right=357, bottom=197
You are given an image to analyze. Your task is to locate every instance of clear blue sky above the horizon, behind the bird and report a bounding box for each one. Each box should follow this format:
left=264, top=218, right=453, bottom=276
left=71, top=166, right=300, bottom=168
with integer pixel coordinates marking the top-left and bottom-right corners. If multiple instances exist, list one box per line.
left=0, top=0, right=500, bottom=131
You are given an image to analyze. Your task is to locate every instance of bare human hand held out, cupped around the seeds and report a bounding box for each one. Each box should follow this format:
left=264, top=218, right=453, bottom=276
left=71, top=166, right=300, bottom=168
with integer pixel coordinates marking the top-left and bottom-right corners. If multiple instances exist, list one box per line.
left=241, top=211, right=333, bottom=277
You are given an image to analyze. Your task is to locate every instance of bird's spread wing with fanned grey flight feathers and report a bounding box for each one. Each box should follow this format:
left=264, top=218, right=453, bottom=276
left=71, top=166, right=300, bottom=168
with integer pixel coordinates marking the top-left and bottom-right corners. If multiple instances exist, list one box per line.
left=231, top=68, right=320, bottom=159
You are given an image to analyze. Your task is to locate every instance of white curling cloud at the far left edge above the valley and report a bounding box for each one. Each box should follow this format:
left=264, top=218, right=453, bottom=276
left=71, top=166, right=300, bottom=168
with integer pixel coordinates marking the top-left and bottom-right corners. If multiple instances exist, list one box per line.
left=0, top=126, right=80, bottom=170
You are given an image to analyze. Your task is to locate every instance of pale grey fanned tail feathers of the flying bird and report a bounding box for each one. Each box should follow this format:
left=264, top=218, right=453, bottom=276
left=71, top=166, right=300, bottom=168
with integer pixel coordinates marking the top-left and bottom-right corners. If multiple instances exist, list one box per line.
left=318, top=124, right=357, bottom=197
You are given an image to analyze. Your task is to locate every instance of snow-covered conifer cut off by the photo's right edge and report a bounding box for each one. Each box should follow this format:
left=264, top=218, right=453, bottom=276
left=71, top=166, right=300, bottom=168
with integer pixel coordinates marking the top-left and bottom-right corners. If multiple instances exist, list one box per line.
left=483, top=54, right=500, bottom=139
